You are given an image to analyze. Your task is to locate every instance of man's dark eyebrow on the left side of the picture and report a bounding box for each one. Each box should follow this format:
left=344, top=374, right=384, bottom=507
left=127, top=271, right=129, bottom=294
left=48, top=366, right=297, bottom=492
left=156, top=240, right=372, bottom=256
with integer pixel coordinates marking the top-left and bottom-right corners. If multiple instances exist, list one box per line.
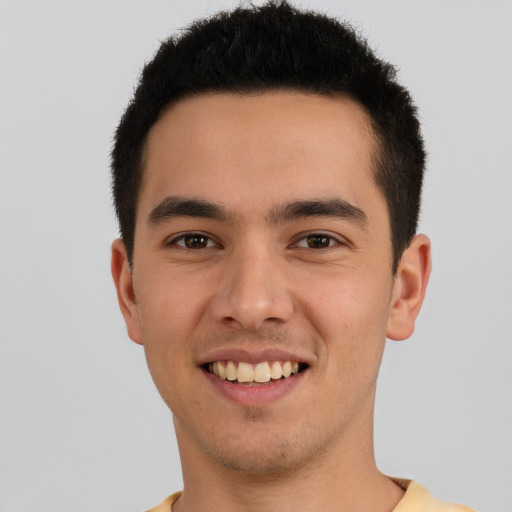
left=147, top=196, right=232, bottom=226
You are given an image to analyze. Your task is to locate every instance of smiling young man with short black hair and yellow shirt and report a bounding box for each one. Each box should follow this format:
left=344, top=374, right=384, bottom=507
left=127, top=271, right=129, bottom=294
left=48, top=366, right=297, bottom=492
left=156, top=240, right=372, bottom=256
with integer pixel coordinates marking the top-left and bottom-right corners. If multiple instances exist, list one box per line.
left=112, top=3, right=469, bottom=512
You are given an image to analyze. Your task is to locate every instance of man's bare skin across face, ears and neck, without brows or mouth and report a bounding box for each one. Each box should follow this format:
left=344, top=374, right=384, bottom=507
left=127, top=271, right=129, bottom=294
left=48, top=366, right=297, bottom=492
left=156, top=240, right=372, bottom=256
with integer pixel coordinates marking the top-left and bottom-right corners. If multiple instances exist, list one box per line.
left=112, top=92, right=430, bottom=512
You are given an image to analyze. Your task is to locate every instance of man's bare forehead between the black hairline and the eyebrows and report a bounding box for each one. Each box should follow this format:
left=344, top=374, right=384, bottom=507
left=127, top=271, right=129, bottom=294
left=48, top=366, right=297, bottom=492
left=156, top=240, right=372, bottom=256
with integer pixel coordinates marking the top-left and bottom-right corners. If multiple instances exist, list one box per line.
left=139, top=91, right=384, bottom=222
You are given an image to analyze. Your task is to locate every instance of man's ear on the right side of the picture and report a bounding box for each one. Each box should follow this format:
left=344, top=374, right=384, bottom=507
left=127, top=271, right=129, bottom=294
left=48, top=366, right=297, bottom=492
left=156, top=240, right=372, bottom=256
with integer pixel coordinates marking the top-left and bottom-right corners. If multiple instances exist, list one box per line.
left=386, top=235, right=432, bottom=340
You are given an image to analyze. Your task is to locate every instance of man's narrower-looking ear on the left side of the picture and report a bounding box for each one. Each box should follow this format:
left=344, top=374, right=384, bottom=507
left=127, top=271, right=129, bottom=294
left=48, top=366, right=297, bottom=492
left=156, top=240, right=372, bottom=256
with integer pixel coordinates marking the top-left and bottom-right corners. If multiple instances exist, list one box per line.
left=111, top=238, right=142, bottom=345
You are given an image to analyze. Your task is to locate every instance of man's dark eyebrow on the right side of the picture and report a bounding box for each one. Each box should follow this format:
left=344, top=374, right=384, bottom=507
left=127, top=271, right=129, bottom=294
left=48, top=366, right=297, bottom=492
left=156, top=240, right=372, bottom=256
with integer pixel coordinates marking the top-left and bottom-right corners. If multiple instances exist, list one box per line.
left=268, top=198, right=368, bottom=228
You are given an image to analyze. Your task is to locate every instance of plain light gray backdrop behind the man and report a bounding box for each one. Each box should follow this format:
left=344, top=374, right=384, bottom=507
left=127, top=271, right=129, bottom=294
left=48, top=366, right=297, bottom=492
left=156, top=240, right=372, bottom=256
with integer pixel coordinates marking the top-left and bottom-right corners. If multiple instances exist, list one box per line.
left=0, top=0, right=512, bottom=512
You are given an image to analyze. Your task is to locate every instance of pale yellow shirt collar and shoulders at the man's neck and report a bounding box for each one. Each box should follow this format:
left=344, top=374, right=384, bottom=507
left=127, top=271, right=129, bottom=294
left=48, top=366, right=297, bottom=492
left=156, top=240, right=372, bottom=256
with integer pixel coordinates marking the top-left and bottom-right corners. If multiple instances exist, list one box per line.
left=147, top=478, right=474, bottom=512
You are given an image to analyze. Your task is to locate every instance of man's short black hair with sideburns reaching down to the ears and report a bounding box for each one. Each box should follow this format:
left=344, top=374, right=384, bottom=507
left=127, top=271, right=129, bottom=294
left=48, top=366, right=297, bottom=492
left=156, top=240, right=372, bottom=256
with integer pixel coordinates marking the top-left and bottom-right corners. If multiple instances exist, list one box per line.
left=112, top=2, right=425, bottom=272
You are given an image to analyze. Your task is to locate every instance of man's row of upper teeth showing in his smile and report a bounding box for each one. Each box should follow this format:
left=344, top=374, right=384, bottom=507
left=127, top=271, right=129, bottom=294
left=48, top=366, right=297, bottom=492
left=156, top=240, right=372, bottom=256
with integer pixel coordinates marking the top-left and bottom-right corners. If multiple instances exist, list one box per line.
left=208, top=361, right=299, bottom=382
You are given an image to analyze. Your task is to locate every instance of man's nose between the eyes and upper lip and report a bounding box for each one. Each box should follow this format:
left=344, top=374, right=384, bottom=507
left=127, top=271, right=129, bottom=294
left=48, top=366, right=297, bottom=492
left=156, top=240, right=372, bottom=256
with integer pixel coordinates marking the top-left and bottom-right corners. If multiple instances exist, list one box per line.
left=211, top=245, right=294, bottom=331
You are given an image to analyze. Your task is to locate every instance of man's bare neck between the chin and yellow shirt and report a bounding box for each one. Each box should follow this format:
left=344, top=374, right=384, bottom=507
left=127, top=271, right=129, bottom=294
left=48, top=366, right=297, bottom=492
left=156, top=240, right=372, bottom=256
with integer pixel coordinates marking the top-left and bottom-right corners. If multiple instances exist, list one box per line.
left=173, top=400, right=404, bottom=512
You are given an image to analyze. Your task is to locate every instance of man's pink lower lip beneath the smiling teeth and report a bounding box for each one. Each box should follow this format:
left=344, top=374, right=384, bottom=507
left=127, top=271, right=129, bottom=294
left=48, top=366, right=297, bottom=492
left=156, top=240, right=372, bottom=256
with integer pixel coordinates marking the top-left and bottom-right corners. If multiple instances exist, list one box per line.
left=200, top=366, right=308, bottom=407
